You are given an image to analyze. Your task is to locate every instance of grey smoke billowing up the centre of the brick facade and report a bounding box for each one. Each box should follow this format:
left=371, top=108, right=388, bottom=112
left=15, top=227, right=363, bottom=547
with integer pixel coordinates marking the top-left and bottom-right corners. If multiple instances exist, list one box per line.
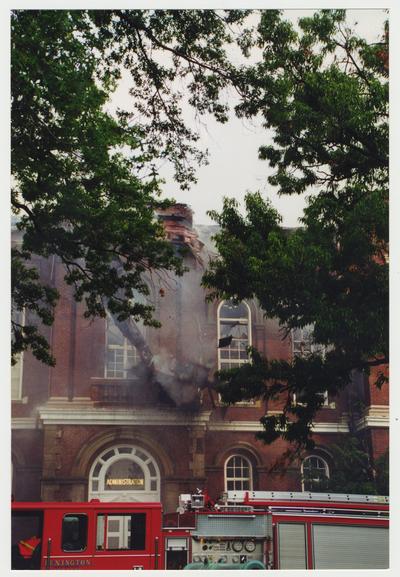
left=114, top=215, right=220, bottom=410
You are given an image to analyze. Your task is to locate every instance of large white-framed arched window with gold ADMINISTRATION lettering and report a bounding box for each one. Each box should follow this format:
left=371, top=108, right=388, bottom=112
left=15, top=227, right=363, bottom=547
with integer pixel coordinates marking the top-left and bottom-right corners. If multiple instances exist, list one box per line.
left=89, top=445, right=160, bottom=501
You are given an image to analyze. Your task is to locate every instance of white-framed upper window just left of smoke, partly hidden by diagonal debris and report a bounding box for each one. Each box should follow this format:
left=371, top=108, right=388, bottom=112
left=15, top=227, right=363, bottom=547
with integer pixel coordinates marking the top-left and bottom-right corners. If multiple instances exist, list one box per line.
left=105, top=314, right=140, bottom=379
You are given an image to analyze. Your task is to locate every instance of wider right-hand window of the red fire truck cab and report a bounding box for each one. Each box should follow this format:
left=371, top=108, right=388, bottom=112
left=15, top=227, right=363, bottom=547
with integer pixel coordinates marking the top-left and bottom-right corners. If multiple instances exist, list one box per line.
left=96, top=513, right=146, bottom=551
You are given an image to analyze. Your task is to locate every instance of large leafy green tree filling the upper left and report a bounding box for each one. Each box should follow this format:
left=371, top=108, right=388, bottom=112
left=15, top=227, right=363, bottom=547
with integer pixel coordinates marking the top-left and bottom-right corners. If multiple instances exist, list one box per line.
left=11, top=10, right=250, bottom=364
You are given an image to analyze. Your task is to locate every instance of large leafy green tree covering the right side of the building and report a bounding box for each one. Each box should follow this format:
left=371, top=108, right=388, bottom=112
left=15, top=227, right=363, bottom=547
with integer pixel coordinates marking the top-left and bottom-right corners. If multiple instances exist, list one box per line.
left=203, top=10, right=388, bottom=447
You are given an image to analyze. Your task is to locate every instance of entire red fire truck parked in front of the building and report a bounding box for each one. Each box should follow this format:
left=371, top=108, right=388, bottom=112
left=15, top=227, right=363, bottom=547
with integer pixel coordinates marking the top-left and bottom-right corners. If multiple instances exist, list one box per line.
left=12, top=491, right=389, bottom=570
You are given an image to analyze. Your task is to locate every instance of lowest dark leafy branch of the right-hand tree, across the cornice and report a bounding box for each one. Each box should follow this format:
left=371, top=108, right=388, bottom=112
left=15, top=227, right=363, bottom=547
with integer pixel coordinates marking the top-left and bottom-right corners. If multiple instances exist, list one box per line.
left=216, top=348, right=349, bottom=449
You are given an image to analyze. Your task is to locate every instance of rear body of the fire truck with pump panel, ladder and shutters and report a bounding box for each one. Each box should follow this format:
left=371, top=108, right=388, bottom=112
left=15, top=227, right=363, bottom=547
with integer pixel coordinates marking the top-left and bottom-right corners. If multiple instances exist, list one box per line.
left=188, top=491, right=389, bottom=569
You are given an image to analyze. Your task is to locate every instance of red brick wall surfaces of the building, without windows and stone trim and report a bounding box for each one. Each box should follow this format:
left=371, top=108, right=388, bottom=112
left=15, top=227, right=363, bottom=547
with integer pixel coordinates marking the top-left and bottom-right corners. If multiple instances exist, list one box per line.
left=13, top=214, right=389, bottom=510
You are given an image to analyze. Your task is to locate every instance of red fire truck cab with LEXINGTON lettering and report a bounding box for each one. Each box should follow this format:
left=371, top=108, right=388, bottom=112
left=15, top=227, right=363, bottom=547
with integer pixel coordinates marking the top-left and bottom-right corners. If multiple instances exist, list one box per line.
left=12, top=500, right=164, bottom=570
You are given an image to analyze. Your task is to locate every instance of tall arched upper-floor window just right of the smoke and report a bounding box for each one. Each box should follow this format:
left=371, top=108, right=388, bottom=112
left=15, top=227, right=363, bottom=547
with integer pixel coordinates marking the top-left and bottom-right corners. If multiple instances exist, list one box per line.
left=218, top=301, right=251, bottom=369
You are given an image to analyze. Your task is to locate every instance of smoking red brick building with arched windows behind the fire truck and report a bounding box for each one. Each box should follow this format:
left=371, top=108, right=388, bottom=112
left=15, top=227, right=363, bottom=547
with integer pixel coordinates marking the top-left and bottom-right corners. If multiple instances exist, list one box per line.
left=12, top=205, right=388, bottom=512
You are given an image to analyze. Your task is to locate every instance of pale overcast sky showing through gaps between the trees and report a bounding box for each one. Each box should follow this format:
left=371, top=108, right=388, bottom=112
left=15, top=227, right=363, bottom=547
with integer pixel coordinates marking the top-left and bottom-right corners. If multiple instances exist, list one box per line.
left=111, top=8, right=387, bottom=226
